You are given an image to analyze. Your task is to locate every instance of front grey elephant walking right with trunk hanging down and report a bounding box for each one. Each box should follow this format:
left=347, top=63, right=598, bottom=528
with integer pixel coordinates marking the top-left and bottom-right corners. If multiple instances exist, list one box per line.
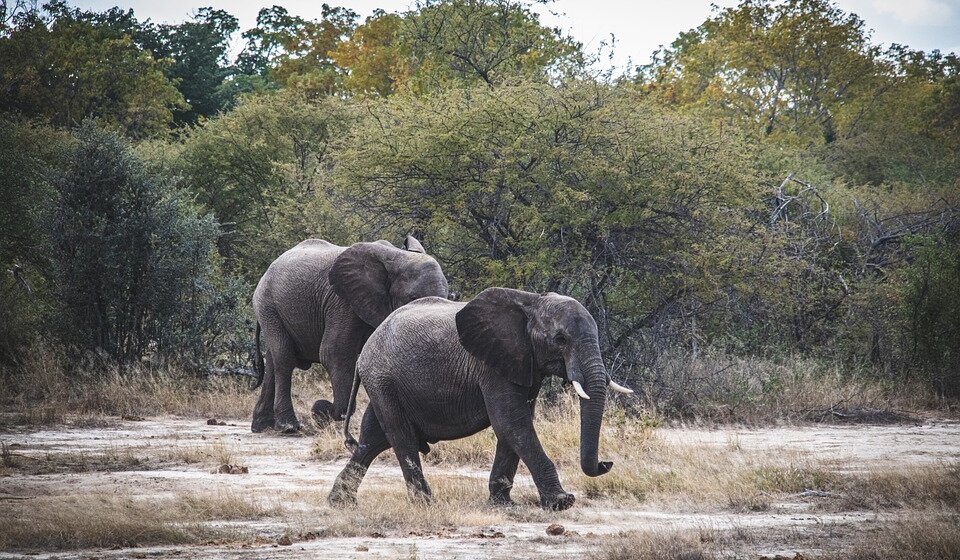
left=328, top=288, right=612, bottom=510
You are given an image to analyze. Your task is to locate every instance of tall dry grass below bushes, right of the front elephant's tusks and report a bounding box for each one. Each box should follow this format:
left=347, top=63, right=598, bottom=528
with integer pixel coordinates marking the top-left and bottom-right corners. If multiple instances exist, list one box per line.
left=631, top=350, right=944, bottom=425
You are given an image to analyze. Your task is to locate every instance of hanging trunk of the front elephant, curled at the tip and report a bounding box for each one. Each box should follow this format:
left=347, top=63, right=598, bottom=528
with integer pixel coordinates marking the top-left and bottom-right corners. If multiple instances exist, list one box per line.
left=567, top=342, right=612, bottom=476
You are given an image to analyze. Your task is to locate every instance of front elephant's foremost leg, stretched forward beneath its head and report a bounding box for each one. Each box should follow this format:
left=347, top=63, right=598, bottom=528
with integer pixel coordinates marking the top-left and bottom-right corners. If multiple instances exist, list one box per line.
left=486, top=393, right=575, bottom=511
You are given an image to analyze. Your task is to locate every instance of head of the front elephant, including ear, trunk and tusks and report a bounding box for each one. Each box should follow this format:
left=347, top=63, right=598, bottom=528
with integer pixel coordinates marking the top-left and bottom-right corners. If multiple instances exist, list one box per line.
left=456, top=288, right=629, bottom=476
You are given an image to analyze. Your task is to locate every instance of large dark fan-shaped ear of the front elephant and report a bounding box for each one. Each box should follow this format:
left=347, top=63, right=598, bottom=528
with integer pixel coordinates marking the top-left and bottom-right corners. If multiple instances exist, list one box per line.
left=456, top=288, right=540, bottom=387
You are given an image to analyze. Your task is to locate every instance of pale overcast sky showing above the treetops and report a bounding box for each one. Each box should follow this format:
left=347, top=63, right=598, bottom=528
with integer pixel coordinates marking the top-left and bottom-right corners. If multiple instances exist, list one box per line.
left=70, top=0, right=960, bottom=70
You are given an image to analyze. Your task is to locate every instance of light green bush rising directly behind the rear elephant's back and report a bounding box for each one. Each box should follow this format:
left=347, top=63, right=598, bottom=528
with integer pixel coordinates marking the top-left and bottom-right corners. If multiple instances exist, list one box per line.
left=162, top=92, right=355, bottom=283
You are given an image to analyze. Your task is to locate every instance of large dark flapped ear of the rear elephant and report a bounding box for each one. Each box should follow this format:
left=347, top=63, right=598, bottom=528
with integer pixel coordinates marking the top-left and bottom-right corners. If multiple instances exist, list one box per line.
left=327, top=241, right=396, bottom=327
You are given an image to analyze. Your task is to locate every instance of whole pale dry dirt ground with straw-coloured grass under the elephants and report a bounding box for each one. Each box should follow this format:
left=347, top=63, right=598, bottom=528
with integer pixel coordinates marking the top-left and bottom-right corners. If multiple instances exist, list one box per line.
left=0, top=417, right=960, bottom=559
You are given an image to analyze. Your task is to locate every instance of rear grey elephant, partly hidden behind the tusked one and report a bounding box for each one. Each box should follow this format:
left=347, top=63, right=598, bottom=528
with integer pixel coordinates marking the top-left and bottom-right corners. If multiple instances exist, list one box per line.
left=251, top=237, right=448, bottom=433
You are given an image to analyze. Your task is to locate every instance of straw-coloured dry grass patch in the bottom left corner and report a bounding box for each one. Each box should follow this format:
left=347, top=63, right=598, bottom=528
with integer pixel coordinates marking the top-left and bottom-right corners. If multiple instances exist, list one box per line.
left=0, top=493, right=281, bottom=550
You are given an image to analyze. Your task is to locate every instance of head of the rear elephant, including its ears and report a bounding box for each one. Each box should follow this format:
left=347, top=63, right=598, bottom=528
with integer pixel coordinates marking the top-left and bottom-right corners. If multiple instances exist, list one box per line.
left=328, top=236, right=449, bottom=327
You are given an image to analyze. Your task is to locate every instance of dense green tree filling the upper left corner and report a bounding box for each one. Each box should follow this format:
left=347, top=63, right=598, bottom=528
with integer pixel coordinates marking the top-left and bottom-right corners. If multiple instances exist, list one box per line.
left=0, top=3, right=187, bottom=138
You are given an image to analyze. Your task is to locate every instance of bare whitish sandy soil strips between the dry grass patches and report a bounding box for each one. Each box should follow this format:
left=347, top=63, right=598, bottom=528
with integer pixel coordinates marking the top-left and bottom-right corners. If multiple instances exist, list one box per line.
left=0, top=417, right=960, bottom=559
